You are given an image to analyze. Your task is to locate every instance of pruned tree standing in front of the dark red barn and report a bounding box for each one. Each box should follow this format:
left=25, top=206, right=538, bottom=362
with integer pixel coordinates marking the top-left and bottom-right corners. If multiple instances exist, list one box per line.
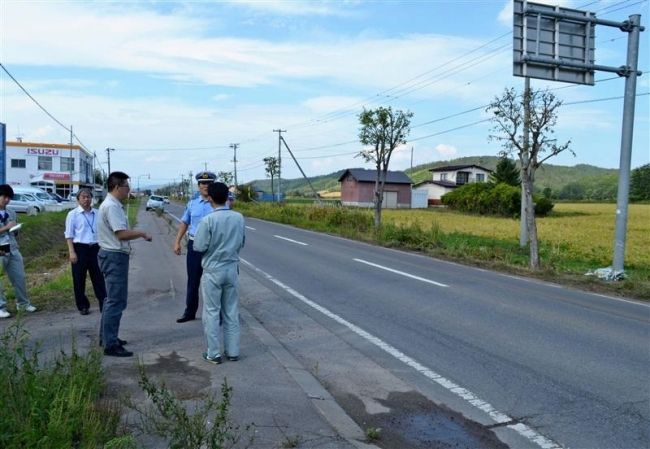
left=359, top=106, right=413, bottom=228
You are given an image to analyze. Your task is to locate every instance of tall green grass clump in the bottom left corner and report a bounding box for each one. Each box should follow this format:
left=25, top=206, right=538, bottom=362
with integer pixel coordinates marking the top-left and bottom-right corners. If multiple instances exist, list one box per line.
left=0, top=321, right=120, bottom=449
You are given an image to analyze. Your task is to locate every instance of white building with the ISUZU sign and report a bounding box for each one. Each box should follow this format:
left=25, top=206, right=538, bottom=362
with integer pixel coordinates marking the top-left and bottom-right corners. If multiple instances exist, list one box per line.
left=0, top=142, right=94, bottom=197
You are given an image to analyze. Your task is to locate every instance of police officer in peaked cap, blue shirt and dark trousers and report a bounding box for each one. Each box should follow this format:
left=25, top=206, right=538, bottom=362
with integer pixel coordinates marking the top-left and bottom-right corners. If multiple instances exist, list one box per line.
left=172, top=171, right=217, bottom=323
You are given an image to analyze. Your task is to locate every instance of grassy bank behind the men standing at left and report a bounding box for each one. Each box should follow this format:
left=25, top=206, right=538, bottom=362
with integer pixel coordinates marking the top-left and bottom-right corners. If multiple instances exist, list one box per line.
left=2, top=198, right=140, bottom=310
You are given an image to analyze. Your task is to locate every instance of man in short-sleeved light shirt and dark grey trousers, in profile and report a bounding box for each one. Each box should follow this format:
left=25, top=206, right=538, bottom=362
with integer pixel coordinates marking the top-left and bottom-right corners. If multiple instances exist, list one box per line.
left=97, top=171, right=151, bottom=357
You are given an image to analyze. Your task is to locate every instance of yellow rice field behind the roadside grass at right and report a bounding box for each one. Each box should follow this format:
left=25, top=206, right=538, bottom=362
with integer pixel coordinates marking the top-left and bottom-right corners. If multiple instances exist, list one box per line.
left=382, top=203, right=650, bottom=271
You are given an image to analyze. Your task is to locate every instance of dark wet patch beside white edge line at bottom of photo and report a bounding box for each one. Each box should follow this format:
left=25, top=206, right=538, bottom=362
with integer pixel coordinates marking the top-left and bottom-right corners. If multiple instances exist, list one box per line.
left=337, top=391, right=508, bottom=449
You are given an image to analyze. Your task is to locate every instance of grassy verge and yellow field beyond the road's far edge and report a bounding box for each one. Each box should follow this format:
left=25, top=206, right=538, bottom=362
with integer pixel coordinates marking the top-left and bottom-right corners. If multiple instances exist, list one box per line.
left=236, top=203, right=650, bottom=299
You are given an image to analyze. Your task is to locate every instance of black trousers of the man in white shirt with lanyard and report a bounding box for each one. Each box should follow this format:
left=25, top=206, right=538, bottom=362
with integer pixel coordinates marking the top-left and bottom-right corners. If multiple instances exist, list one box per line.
left=70, top=243, right=106, bottom=311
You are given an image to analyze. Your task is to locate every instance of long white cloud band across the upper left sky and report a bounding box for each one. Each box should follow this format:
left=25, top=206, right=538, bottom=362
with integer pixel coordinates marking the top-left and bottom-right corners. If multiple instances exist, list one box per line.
left=3, top=2, right=503, bottom=97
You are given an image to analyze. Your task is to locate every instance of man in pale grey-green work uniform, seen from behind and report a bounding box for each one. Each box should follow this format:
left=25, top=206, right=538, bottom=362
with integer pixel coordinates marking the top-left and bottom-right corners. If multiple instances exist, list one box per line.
left=194, top=182, right=245, bottom=364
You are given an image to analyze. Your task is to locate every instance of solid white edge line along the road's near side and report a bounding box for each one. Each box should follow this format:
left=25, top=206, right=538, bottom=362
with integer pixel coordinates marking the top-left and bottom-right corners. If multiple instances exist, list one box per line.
left=240, top=258, right=562, bottom=449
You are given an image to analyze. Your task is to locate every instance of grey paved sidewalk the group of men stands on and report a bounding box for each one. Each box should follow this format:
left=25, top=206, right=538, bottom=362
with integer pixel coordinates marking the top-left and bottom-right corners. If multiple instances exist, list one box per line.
left=0, top=206, right=375, bottom=449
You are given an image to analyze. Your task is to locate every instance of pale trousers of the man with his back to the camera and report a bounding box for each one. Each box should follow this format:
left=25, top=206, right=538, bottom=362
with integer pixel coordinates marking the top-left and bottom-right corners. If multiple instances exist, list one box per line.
left=201, top=263, right=240, bottom=358
